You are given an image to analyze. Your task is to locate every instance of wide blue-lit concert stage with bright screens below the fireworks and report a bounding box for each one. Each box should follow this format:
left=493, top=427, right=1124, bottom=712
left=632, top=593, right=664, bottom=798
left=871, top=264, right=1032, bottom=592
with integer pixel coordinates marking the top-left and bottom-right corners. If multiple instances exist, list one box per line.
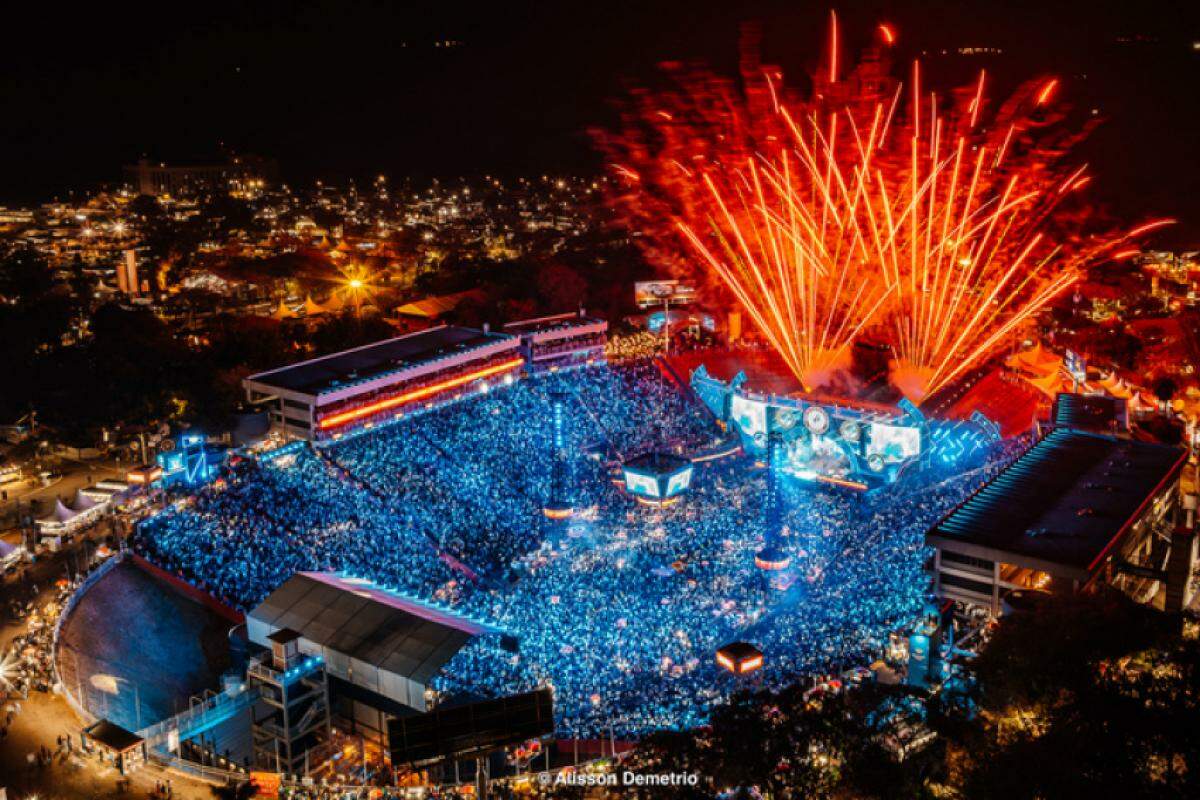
left=691, top=366, right=1000, bottom=491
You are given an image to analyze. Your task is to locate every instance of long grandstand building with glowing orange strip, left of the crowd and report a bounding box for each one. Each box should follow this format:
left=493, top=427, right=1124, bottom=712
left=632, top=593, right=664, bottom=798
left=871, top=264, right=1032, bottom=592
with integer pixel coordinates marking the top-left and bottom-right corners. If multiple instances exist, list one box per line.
left=242, top=325, right=526, bottom=440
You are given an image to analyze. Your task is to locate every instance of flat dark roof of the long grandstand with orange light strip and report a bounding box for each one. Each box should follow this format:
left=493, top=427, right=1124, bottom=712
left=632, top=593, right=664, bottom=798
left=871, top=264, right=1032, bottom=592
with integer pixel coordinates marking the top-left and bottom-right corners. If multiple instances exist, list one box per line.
left=247, top=325, right=511, bottom=395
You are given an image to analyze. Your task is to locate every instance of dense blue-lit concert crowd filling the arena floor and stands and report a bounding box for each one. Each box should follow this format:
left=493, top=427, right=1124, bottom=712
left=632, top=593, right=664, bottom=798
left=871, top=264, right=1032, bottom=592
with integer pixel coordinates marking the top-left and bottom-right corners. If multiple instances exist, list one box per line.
left=136, top=361, right=1032, bottom=738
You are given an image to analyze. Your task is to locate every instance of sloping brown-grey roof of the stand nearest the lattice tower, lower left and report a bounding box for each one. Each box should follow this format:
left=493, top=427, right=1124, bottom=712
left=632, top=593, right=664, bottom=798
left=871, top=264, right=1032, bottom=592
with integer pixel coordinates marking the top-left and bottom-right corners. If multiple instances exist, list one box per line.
left=250, top=572, right=497, bottom=684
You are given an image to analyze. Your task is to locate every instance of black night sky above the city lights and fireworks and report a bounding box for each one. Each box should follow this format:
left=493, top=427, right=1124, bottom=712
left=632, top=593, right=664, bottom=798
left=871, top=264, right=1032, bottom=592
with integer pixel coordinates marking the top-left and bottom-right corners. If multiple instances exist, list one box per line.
left=0, top=0, right=1200, bottom=247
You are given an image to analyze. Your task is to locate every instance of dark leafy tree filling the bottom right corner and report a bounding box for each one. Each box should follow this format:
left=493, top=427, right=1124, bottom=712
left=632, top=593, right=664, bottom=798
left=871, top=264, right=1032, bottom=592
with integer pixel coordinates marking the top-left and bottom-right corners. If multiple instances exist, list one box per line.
left=962, top=593, right=1200, bottom=798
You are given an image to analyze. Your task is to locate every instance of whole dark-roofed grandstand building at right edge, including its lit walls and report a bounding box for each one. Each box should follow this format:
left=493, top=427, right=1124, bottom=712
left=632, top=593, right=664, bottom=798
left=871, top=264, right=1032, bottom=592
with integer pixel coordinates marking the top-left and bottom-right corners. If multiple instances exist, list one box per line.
left=925, top=428, right=1195, bottom=614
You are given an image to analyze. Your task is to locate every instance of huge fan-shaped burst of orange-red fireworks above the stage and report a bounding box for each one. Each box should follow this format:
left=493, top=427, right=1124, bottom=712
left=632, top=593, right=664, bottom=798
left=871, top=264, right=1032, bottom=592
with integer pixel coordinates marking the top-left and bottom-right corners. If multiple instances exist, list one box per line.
left=600, top=16, right=1170, bottom=401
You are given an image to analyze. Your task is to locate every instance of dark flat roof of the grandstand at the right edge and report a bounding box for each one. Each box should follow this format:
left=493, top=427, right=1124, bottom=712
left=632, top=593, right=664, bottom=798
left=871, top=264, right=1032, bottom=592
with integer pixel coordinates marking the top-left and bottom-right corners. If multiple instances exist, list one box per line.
left=925, top=428, right=1187, bottom=577
